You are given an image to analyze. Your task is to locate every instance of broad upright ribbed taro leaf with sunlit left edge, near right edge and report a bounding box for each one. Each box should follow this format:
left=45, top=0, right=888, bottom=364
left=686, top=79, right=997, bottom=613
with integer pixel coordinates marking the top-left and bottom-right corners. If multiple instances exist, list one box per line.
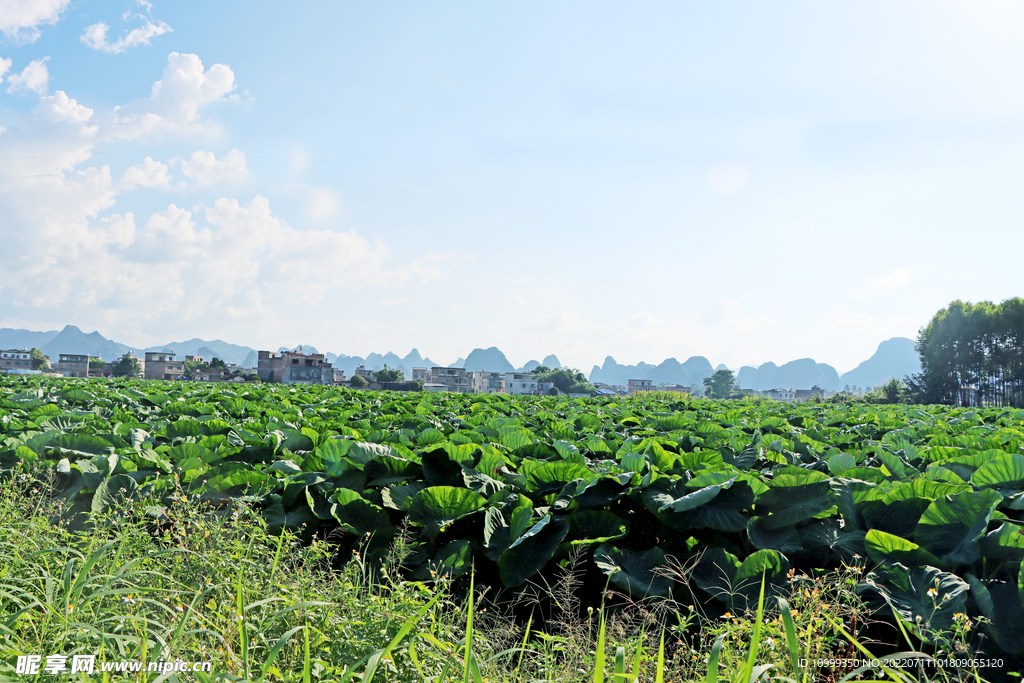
left=913, top=490, right=1002, bottom=566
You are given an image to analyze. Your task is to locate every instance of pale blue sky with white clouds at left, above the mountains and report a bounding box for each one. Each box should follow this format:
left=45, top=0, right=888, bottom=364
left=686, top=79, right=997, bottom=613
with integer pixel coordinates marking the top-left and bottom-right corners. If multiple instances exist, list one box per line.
left=0, top=0, right=1024, bottom=372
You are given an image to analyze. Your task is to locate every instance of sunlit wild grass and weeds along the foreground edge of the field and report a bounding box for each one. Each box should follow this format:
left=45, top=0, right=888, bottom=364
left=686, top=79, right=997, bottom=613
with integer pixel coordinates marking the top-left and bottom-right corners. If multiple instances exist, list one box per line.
left=0, top=482, right=984, bottom=683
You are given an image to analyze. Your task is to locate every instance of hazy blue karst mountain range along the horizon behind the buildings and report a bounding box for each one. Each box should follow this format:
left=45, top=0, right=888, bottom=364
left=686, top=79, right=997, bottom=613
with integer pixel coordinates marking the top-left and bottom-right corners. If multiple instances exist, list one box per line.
left=0, top=325, right=921, bottom=391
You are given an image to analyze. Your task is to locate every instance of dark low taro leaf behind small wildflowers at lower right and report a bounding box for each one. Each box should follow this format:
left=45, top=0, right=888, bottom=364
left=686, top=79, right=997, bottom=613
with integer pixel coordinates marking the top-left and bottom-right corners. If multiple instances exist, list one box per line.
left=857, top=562, right=969, bottom=639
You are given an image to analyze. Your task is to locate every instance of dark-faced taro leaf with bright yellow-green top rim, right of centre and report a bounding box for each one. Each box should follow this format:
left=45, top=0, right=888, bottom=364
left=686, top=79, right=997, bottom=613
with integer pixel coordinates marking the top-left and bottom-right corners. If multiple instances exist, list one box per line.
left=755, top=467, right=837, bottom=531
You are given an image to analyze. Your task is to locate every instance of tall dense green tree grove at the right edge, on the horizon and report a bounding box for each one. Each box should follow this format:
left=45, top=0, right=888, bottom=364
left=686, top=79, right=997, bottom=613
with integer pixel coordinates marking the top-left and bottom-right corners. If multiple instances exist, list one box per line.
left=905, top=297, right=1024, bottom=408
